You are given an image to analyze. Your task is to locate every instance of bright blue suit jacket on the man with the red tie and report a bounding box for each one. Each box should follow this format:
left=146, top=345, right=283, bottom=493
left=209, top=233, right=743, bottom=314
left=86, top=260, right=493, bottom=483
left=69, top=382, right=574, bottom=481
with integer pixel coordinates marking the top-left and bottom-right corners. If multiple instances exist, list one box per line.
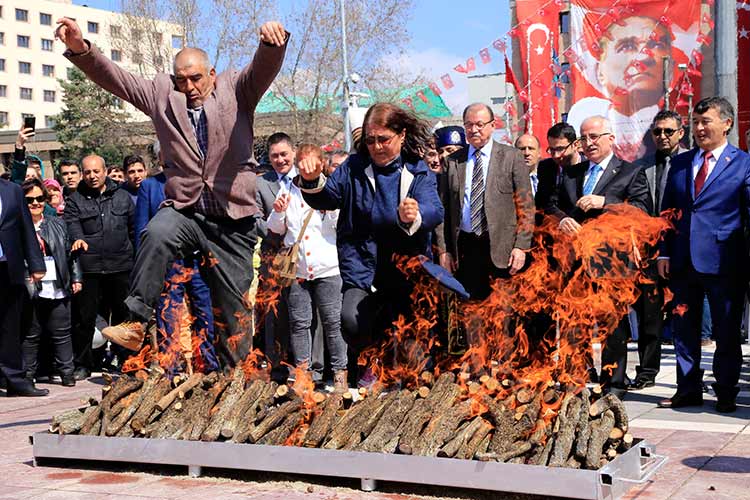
left=661, top=144, right=750, bottom=274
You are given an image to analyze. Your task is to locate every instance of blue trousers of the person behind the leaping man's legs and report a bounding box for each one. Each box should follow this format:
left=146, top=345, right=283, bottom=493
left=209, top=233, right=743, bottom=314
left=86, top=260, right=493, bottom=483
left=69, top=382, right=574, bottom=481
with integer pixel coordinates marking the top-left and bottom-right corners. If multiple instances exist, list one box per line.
left=156, top=260, right=219, bottom=373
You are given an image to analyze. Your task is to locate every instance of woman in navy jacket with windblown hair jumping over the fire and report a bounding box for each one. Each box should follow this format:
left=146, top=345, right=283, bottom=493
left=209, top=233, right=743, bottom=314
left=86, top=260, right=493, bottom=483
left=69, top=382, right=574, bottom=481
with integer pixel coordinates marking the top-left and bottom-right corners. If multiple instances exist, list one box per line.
left=295, top=103, right=443, bottom=385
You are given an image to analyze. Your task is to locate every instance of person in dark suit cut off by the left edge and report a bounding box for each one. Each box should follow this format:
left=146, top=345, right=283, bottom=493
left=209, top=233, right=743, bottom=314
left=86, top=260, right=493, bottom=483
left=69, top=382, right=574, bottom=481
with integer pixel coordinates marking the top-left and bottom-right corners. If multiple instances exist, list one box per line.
left=0, top=179, right=49, bottom=396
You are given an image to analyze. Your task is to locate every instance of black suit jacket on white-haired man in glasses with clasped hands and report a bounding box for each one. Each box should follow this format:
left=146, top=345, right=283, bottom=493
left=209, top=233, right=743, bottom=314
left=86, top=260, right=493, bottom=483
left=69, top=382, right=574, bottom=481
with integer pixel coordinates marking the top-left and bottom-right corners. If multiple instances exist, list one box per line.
left=548, top=156, right=652, bottom=223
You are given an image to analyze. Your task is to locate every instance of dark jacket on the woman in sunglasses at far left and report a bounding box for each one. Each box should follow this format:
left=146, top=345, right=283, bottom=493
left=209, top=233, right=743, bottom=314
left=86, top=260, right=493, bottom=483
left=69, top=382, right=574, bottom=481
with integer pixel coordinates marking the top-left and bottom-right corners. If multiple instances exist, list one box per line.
left=28, top=217, right=83, bottom=296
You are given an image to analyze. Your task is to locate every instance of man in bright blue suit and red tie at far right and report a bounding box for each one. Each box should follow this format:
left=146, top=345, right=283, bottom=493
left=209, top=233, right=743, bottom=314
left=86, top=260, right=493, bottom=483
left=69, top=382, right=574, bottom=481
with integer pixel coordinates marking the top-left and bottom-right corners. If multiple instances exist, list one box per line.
left=657, top=97, right=750, bottom=413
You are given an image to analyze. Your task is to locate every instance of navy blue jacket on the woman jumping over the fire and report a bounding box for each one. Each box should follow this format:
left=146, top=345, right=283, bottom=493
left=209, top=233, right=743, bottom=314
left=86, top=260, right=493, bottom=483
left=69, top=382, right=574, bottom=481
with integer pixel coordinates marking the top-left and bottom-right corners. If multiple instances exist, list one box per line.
left=303, top=154, right=443, bottom=290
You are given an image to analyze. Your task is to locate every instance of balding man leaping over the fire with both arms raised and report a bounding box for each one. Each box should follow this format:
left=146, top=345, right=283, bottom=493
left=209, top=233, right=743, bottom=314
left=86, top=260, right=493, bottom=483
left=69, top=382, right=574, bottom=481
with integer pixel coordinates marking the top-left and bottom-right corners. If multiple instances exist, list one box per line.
left=57, top=18, right=289, bottom=366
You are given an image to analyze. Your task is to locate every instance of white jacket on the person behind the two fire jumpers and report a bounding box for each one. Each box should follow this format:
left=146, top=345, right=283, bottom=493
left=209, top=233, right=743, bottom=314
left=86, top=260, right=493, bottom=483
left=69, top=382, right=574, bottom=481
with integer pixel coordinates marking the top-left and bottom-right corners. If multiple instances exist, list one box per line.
left=266, top=182, right=339, bottom=280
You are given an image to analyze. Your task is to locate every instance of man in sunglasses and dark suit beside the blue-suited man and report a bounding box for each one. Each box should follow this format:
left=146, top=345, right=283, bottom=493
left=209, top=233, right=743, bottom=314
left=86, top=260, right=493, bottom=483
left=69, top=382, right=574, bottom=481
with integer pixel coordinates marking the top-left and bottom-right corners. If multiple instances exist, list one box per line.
left=629, top=110, right=686, bottom=390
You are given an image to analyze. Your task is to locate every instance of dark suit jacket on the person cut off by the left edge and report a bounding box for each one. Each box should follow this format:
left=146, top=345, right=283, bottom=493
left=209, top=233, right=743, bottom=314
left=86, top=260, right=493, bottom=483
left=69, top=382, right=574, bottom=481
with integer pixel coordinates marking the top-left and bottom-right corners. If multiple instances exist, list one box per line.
left=0, top=179, right=46, bottom=285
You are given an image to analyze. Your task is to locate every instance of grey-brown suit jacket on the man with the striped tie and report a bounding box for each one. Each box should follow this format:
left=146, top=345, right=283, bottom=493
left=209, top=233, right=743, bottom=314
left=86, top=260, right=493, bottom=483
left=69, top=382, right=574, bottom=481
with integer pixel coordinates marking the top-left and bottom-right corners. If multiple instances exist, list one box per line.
left=436, top=142, right=534, bottom=269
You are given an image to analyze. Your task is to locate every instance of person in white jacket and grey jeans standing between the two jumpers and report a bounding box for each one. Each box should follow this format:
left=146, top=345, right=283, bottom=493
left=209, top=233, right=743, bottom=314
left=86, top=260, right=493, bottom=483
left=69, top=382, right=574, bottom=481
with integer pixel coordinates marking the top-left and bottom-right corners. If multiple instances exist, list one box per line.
left=267, top=144, right=348, bottom=392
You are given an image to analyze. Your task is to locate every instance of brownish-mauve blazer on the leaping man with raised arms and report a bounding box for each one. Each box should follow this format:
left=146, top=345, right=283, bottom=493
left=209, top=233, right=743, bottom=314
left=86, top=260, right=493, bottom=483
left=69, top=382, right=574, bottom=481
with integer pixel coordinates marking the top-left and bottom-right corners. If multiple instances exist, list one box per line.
left=66, top=38, right=286, bottom=219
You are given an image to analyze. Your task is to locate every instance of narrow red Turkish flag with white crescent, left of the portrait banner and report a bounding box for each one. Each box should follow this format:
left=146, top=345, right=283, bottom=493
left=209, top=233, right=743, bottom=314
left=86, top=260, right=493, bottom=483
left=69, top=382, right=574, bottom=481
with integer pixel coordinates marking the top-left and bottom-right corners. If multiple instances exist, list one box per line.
left=506, top=0, right=560, bottom=150
